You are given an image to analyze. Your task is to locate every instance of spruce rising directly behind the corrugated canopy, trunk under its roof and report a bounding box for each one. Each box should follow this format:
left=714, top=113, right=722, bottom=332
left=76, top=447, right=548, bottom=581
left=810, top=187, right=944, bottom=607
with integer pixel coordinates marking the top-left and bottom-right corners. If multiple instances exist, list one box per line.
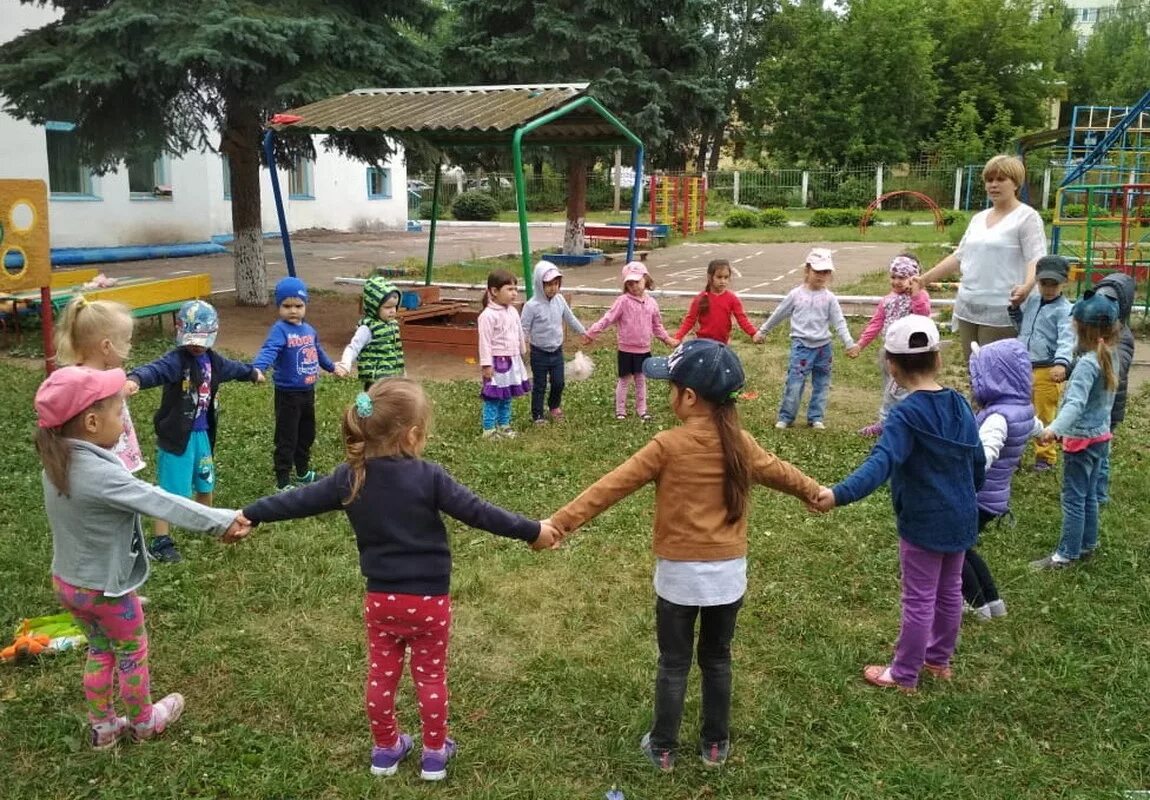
left=445, top=0, right=721, bottom=253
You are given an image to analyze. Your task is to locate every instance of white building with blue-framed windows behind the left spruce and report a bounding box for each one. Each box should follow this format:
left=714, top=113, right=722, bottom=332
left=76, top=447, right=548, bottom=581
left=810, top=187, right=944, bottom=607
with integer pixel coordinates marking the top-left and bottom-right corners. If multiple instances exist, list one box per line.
left=0, top=0, right=407, bottom=247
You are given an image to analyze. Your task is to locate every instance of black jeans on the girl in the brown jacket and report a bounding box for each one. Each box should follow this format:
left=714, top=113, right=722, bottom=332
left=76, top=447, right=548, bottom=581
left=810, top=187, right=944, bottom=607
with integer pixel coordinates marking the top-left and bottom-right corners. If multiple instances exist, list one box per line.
left=651, top=598, right=743, bottom=751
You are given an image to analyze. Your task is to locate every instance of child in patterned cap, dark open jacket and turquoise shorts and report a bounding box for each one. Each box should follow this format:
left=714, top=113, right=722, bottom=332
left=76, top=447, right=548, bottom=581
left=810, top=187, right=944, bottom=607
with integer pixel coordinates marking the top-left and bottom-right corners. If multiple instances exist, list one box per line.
left=124, top=300, right=263, bottom=563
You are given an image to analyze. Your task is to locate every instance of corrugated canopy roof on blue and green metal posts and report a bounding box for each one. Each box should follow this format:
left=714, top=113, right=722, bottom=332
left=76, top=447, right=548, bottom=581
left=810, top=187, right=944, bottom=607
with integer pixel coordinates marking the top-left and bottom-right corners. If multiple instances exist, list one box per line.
left=269, top=84, right=628, bottom=146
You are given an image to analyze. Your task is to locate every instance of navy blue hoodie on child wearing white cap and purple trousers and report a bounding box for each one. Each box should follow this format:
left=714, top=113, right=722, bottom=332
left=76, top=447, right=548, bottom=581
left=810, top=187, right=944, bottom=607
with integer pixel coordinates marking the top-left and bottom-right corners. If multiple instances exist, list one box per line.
left=834, top=389, right=987, bottom=553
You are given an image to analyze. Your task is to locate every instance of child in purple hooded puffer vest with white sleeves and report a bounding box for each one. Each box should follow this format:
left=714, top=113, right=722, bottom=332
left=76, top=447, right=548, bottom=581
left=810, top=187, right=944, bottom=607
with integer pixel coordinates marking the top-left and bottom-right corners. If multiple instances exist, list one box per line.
left=963, top=339, right=1043, bottom=621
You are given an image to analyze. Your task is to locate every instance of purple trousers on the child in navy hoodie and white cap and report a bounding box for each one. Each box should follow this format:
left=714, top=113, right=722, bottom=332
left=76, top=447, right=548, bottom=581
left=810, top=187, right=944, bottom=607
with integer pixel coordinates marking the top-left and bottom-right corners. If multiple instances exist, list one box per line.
left=890, top=539, right=966, bottom=686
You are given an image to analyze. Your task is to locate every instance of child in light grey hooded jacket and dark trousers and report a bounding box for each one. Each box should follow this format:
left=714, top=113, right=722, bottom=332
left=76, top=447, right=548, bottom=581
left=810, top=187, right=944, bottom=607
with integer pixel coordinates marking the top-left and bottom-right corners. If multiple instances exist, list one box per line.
left=521, top=261, right=587, bottom=424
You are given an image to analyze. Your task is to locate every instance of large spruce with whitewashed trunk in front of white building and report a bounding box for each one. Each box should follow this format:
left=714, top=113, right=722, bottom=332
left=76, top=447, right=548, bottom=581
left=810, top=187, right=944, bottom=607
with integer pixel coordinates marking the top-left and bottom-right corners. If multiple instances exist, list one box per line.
left=0, top=0, right=435, bottom=306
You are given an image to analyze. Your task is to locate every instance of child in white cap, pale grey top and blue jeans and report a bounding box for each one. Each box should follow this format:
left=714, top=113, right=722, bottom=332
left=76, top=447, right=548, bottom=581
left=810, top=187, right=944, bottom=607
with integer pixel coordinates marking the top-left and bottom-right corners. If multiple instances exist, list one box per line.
left=754, top=247, right=854, bottom=430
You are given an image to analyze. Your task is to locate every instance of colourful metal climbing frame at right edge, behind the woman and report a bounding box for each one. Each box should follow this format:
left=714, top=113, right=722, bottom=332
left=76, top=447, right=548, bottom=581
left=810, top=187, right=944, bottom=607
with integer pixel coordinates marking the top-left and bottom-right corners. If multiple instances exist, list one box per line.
left=1051, top=92, right=1150, bottom=314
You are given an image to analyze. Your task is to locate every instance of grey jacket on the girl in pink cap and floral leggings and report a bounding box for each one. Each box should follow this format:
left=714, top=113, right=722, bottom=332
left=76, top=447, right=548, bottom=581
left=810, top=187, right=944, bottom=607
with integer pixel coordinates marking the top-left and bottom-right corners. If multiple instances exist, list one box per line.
left=48, top=439, right=236, bottom=598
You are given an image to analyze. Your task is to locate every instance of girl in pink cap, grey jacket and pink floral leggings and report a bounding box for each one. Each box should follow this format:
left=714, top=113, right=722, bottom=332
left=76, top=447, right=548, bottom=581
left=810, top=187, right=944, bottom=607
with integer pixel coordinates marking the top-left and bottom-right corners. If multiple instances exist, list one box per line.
left=36, top=367, right=250, bottom=749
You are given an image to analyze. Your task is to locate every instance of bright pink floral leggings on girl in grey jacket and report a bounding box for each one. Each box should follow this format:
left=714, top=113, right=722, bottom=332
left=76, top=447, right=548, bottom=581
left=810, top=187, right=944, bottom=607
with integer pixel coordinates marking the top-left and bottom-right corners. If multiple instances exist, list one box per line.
left=52, top=576, right=152, bottom=725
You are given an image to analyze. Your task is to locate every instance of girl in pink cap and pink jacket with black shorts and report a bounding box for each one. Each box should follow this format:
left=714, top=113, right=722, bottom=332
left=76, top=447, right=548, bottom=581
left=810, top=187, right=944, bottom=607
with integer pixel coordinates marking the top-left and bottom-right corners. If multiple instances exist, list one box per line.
left=583, top=261, right=675, bottom=422
